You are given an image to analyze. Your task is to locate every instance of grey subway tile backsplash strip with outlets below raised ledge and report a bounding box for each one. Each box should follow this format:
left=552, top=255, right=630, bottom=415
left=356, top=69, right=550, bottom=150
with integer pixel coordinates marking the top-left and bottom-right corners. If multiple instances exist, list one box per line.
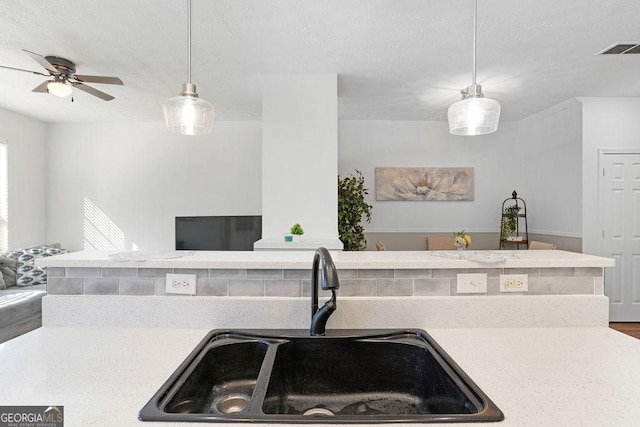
left=47, top=267, right=604, bottom=298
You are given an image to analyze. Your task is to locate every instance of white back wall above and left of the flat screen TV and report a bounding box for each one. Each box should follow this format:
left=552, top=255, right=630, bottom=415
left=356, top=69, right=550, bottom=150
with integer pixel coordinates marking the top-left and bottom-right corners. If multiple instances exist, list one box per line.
left=42, top=122, right=262, bottom=250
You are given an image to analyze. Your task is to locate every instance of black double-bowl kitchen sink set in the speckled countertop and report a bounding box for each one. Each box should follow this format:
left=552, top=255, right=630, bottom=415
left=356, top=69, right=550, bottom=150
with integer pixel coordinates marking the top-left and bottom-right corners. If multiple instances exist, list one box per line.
left=139, top=330, right=504, bottom=423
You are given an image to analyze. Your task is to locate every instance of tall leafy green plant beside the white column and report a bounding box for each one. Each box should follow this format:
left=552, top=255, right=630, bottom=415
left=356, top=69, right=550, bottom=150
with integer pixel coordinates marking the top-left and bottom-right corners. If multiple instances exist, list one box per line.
left=338, top=170, right=373, bottom=251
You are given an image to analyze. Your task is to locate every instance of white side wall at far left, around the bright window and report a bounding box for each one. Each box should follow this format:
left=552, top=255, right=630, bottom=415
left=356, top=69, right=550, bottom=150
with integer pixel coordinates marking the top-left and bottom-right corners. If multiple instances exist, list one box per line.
left=0, top=105, right=47, bottom=249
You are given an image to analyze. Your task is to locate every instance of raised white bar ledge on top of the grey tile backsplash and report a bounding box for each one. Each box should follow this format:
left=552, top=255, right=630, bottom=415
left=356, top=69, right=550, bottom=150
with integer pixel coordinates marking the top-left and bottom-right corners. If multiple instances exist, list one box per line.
left=38, top=250, right=614, bottom=269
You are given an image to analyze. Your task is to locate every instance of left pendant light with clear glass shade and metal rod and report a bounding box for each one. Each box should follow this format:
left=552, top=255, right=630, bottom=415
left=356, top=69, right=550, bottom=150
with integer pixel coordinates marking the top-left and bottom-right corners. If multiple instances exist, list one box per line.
left=162, top=0, right=214, bottom=135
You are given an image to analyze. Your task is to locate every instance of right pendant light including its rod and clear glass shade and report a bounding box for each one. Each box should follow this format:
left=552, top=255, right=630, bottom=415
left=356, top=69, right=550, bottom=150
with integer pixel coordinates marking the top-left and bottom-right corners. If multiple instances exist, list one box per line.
left=447, top=0, right=500, bottom=135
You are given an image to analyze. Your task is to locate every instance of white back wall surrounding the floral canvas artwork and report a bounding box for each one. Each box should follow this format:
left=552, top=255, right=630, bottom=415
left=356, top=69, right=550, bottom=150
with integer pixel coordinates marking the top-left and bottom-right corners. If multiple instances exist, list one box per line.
left=338, top=121, right=524, bottom=233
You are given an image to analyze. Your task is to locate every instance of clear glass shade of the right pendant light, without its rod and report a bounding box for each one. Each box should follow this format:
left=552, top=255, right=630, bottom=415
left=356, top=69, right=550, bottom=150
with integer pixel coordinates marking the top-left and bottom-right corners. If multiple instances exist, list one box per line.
left=447, top=98, right=500, bottom=135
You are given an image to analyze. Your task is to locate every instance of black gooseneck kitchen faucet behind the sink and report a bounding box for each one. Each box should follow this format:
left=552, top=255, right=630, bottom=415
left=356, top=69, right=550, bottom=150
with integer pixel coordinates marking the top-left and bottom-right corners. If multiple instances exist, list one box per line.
left=309, top=248, right=340, bottom=335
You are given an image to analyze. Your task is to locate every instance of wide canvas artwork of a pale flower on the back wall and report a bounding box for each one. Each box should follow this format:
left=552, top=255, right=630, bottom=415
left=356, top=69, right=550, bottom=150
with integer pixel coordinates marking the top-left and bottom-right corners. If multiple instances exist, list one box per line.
left=376, top=168, right=474, bottom=200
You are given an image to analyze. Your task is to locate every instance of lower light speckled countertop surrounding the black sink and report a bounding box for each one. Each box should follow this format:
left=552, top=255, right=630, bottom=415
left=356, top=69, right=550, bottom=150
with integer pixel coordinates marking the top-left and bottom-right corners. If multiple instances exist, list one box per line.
left=0, top=327, right=640, bottom=427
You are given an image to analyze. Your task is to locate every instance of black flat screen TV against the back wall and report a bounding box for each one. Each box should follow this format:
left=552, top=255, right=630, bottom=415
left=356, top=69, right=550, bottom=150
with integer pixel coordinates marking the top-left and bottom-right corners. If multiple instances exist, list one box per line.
left=176, top=215, right=262, bottom=251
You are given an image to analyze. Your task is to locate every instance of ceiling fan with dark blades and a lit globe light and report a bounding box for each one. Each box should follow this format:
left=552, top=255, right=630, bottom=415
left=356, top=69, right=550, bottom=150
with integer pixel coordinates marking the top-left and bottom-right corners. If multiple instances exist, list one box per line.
left=0, top=49, right=124, bottom=101
